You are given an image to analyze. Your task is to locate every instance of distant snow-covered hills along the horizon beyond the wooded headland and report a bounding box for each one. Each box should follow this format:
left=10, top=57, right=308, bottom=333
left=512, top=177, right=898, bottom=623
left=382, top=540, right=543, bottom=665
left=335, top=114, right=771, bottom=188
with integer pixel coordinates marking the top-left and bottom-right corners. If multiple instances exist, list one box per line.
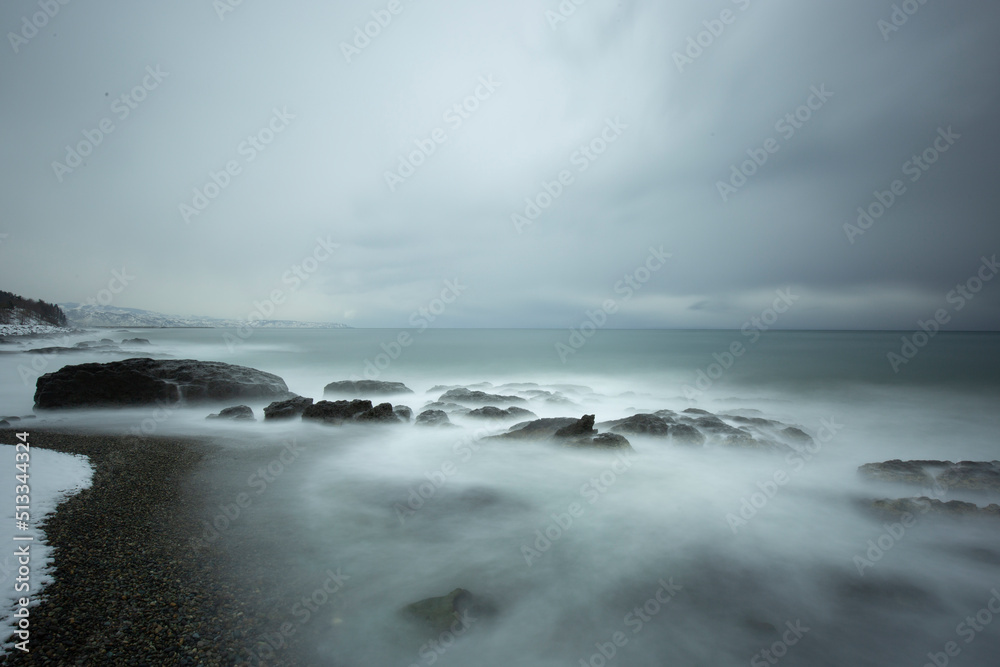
left=60, top=303, right=350, bottom=329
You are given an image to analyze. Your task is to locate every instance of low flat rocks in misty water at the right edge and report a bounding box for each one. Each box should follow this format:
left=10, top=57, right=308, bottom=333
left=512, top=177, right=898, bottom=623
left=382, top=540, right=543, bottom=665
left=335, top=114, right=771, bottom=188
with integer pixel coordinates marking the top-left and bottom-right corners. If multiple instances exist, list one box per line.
left=858, top=459, right=1000, bottom=519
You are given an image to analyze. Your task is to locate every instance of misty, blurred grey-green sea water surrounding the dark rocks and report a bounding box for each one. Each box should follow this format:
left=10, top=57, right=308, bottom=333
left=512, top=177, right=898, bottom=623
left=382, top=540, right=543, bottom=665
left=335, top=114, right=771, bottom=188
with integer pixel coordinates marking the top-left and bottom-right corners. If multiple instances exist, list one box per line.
left=0, top=330, right=1000, bottom=667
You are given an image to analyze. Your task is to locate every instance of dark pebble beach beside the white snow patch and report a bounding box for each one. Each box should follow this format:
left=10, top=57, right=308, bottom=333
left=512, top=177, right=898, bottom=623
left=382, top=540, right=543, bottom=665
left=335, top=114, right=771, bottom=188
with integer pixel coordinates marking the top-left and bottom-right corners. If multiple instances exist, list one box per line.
left=0, top=425, right=299, bottom=666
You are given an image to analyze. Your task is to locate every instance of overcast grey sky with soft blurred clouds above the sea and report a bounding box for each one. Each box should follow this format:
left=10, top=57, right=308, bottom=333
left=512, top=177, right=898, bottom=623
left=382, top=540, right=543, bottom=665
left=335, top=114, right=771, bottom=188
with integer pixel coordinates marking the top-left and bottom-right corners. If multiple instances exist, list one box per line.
left=0, top=0, right=1000, bottom=329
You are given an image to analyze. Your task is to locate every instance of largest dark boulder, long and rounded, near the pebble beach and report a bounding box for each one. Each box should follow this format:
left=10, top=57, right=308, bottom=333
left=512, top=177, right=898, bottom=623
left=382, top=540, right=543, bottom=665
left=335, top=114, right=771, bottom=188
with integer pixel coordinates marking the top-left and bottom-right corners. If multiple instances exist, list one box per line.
left=35, top=359, right=289, bottom=410
